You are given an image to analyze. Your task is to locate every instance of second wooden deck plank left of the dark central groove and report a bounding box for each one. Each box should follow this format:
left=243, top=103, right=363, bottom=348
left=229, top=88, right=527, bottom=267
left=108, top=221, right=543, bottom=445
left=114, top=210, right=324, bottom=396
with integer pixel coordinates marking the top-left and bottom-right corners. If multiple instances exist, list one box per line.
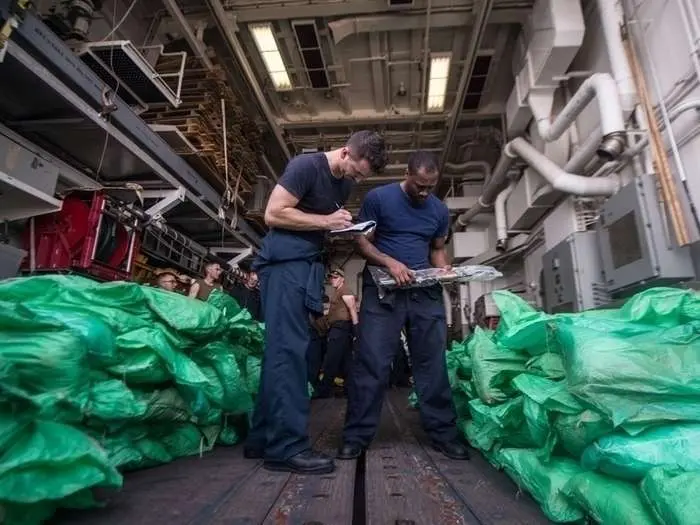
left=200, top=400, right=337, bottom=525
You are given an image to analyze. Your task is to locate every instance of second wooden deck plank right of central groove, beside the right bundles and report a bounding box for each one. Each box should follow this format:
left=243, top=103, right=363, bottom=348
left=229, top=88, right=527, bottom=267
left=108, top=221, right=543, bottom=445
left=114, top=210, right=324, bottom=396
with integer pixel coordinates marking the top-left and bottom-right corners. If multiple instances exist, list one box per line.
left=388, top=390, right=551, bottom=525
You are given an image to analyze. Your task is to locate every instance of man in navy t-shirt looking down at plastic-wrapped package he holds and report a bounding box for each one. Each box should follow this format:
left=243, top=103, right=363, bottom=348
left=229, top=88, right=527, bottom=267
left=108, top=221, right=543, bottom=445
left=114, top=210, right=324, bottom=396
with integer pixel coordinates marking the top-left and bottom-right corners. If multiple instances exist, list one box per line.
left=338, top=151, right=469, bottom=459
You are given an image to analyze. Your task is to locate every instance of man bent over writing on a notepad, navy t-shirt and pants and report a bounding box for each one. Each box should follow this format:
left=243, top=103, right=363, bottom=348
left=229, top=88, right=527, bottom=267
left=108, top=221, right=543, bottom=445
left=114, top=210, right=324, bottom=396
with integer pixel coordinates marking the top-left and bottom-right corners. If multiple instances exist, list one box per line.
left=244, top=131, right=386, bottom=474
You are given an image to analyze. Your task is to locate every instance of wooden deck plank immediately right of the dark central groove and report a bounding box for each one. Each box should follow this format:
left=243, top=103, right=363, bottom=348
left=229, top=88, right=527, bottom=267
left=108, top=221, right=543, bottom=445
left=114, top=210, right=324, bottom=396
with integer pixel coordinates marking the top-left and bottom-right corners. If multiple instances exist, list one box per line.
left=365, top=392, right=479, bottom=525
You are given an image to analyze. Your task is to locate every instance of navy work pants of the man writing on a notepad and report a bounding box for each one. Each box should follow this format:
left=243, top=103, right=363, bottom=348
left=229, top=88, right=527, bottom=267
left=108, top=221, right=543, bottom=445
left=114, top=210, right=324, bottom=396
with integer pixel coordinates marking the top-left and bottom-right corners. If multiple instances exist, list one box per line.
left=247, top=261, right=311, bottom=460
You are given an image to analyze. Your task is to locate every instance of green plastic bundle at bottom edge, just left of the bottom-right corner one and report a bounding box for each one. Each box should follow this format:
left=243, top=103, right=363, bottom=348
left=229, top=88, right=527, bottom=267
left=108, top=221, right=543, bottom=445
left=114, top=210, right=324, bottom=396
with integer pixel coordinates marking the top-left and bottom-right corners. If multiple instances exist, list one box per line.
left=563, top=472, right=667, bottom=525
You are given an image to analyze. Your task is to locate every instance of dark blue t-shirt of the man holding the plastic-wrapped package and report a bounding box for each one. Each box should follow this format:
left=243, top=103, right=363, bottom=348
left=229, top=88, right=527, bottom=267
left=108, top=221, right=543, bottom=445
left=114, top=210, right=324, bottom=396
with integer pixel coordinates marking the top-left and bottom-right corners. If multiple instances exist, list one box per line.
left=359, top=183, right=450, bottom=270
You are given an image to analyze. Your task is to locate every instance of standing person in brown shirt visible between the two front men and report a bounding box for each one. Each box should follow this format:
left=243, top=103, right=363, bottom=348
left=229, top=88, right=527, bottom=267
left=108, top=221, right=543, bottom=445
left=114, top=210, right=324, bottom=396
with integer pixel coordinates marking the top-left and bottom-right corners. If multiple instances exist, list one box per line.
left=318, top=269, right=358, bottom=397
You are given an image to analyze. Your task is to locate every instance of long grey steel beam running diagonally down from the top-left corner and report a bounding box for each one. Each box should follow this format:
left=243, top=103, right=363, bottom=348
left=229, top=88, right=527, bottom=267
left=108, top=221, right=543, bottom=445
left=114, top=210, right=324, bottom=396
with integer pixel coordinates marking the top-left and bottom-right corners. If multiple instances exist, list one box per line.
left=0, top=0, right=260, bottom=244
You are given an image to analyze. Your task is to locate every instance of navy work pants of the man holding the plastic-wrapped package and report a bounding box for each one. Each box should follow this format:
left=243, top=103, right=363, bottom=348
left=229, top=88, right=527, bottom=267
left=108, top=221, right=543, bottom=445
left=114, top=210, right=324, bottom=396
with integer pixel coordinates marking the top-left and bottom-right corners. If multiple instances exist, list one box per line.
left=343, top=286, right=457, bottom=447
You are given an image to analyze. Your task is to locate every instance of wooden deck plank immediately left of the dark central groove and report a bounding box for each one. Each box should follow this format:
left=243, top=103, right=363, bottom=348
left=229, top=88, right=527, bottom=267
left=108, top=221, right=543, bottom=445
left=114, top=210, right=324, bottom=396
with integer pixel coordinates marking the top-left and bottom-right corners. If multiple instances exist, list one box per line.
left=264, top=399, right=357, bottom=525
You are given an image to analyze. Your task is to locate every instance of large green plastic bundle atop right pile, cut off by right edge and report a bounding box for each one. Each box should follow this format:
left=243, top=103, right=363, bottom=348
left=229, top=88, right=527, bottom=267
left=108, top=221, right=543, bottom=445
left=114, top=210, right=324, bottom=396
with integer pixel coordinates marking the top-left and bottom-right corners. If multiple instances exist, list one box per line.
left=554, top=288, right=700, bottom=434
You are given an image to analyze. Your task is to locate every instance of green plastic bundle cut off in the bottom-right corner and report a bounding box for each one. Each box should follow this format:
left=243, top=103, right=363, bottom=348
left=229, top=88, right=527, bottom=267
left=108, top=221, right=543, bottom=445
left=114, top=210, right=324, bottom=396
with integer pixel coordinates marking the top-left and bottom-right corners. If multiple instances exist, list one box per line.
left=641, top=467, right=700, bottom=525
